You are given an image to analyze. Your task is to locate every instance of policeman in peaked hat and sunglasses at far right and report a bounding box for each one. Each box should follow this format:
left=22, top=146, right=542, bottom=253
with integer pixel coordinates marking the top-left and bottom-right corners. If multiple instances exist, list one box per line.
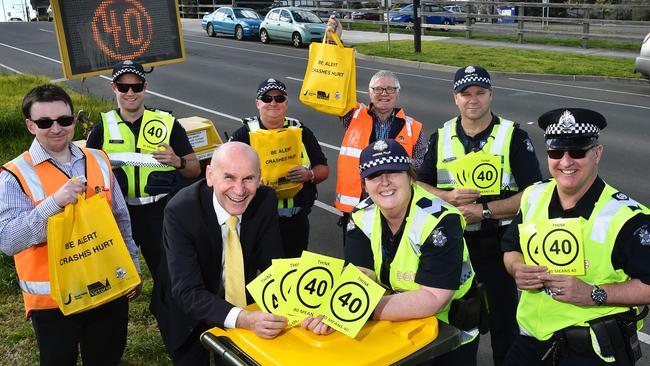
left=502, top=108, right=650, bottom=366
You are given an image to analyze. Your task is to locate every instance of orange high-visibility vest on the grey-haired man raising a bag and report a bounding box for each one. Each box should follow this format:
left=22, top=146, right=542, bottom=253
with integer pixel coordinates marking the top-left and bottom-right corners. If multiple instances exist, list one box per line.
left=334, top=104, right=422, bottom=212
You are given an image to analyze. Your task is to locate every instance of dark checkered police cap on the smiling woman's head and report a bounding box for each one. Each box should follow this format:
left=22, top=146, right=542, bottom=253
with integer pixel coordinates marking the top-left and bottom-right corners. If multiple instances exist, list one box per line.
left=359, top=140, right=411, bottom=179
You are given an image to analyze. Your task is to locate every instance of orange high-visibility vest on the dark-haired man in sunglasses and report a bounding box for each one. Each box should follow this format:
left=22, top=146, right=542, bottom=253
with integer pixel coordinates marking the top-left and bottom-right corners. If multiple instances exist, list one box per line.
left=3, top=148, right=113, bottom=317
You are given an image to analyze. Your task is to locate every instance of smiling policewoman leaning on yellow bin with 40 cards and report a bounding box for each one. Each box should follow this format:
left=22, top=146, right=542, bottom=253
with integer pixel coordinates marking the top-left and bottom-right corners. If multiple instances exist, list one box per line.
left=303, top=140, right=478, bottom=365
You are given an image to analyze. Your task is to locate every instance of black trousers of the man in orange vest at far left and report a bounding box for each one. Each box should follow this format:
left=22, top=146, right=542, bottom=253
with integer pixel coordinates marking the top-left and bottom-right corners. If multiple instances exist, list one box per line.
left=31, top=297, right=129, bottom=366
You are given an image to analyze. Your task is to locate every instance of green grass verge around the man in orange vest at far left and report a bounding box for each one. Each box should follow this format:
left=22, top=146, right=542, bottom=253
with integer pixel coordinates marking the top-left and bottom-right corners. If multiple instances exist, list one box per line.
left=0, top=74, right=171, bottom=366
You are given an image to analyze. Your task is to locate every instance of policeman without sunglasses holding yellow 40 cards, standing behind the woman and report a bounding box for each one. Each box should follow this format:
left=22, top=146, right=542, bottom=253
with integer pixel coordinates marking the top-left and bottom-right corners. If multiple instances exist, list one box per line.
left=418, top=66, right=542, bottom=366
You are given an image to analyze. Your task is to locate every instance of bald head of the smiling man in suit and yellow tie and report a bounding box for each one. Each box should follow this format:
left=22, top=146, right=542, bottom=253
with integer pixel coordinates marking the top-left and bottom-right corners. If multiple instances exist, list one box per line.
left=205, top=141, right=261, bottom=216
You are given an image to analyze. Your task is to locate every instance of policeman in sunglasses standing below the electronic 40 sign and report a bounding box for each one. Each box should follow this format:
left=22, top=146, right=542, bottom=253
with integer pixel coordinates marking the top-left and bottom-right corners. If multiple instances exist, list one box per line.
left=86, top=61, right=201, bottom=282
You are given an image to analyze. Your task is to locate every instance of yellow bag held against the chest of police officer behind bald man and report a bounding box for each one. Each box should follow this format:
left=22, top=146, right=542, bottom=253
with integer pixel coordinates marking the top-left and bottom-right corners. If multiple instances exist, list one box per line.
left=249, top=127, right=302, bottom=199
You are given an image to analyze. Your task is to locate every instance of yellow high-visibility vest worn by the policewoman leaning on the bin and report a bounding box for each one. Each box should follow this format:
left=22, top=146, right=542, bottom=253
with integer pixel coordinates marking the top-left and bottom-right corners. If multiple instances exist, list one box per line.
left=352, top=185, right=478, bottom=344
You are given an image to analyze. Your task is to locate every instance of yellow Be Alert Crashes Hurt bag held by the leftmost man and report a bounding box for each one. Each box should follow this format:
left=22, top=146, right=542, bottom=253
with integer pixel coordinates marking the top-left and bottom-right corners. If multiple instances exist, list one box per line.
left=47, top=194, right=140, bottom=315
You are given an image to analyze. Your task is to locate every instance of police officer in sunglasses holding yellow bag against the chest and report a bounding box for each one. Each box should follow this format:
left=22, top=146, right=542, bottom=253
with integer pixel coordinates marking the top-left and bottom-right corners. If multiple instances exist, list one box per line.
left=231, top=78, right=329, bottom=258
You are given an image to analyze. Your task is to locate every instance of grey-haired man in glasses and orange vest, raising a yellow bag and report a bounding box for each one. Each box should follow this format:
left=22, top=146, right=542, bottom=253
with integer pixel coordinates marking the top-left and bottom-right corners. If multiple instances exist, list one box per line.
left=334, top=70, right=427, bottom=244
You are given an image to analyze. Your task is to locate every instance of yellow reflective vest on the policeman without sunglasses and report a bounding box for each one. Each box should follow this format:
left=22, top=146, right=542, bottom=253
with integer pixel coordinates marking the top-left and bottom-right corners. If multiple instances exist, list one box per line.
left=436, top=117, right=518, bottom=191
